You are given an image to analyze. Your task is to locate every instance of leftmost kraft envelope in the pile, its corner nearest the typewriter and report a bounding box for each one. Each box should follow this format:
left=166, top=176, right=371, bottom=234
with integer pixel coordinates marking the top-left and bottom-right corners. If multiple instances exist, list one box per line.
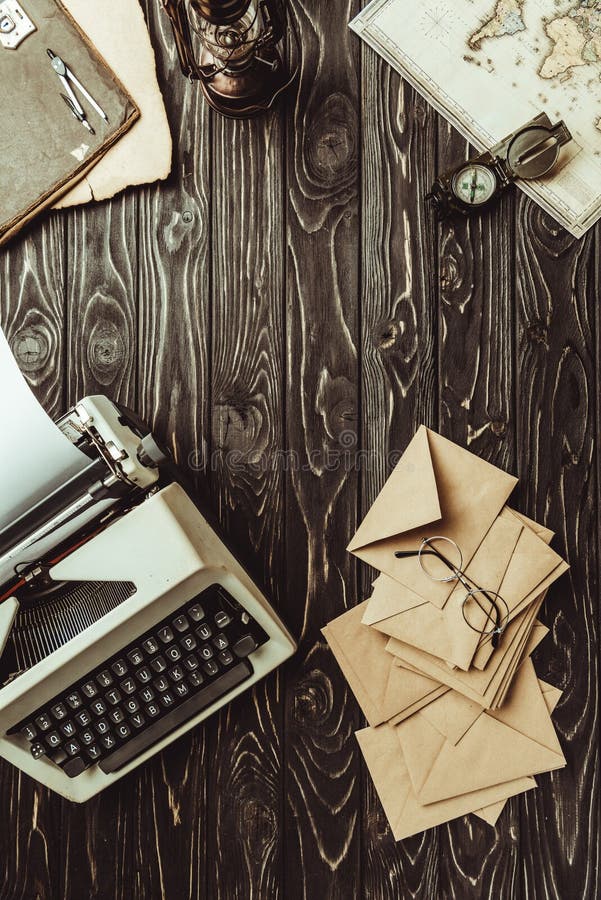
left=322, top=603, right=449, bottom=726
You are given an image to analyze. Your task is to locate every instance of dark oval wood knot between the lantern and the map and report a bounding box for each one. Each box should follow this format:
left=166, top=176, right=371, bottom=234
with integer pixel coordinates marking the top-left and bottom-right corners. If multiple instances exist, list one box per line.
left=305, top=94, right=357, bottom=188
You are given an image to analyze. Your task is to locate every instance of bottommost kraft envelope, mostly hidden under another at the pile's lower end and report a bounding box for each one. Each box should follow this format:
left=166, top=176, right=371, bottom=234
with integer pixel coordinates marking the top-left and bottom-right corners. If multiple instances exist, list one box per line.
left=355, top=724, right=535, bottom=841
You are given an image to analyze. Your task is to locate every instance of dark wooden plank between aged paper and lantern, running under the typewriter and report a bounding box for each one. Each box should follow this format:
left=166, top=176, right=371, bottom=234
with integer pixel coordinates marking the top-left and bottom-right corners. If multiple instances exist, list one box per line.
left=116, top=2, right=211, bottom=900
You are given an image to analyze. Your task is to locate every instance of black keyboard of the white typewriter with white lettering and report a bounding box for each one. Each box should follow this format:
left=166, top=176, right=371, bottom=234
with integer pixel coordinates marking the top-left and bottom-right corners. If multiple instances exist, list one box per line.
left=8, top=585, right=268, bottom=778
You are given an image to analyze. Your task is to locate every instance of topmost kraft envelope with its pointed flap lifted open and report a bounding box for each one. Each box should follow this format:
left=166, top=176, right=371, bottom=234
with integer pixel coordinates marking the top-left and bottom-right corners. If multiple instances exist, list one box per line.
left=347, top=425, right=517, bottom=608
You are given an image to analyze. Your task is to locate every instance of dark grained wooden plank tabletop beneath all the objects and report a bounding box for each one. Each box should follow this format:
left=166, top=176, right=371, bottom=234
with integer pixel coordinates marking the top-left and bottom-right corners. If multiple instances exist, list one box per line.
left=0, top=0, right=601, bottom=900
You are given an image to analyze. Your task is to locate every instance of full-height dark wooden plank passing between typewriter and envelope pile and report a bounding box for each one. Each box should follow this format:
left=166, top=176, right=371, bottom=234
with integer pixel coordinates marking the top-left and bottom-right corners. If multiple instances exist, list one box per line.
left=283, top=0, right=361, bottom=900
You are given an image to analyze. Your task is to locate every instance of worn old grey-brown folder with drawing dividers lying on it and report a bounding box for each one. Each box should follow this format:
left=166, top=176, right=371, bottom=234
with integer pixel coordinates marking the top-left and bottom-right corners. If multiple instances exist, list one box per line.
left=0, top=0, right=140, bottom=246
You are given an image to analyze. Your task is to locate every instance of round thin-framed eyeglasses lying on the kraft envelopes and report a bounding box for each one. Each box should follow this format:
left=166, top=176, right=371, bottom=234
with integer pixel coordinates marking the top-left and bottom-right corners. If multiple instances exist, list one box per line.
left=394, top=534, right=509, bottom=647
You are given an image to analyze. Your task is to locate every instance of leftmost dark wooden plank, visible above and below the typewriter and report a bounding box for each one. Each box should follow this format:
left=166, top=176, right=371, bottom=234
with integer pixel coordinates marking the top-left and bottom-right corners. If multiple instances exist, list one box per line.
left=0, top=214, right=65, bottom=900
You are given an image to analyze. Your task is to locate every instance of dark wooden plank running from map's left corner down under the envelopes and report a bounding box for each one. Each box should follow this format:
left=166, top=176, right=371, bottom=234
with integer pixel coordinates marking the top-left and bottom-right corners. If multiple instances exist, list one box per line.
left=358, top=46, right=438, bottom=900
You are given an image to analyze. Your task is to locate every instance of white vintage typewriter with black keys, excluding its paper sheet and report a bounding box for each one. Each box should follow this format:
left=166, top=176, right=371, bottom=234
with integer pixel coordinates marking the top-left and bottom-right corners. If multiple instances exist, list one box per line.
left=0, top=396, right=295, bottom=802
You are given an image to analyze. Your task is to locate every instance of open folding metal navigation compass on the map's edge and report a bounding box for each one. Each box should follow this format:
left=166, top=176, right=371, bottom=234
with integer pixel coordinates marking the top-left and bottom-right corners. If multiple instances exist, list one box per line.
left=426, top=113, right=572, bottom=219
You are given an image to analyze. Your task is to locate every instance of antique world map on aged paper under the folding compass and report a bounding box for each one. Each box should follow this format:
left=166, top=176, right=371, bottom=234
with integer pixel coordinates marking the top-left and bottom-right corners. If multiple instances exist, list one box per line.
left=351, top=0, right=601, bottom=237
